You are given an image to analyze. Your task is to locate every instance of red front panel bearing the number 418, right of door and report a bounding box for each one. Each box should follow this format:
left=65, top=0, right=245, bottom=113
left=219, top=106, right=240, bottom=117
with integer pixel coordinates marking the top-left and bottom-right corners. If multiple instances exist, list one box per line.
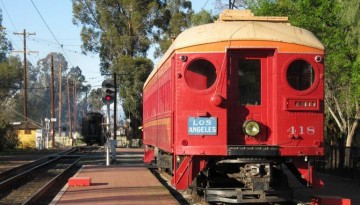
left=273, top=54, right=324, bottom=156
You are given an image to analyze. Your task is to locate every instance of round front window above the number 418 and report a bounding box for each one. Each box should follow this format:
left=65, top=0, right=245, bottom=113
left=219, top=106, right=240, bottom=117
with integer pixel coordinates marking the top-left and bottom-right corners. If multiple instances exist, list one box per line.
left=286, top=60, right=315, bottom=91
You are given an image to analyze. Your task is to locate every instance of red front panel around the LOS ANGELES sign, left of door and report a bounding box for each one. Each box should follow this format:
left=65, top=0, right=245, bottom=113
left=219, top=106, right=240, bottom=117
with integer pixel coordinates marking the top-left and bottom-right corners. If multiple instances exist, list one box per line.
left=174, top=53, right=227, bottom=155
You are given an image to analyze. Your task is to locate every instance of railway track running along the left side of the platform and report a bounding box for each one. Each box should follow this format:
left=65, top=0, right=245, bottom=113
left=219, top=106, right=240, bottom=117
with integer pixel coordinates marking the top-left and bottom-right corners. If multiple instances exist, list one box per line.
left=0, top=149, right=94, bottom=205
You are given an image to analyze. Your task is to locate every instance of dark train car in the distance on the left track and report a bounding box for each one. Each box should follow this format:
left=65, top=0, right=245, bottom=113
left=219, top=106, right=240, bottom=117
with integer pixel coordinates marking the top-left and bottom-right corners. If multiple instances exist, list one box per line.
left=81, top=112, right=106, bottom=145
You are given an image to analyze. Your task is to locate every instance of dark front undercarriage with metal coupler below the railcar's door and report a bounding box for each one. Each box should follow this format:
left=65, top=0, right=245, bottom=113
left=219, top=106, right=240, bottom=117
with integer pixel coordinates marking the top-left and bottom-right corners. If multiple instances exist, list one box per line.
left=192, top=158, right=292, bottom=203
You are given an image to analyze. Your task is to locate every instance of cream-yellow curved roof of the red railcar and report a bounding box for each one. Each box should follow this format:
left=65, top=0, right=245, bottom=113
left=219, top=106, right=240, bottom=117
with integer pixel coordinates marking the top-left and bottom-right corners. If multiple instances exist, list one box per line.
left=144, top=10, right=324, bottom=87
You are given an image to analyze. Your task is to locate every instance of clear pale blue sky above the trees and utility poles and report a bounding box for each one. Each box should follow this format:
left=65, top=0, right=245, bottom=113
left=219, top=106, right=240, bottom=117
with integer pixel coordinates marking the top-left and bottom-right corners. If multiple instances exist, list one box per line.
left=0, top=0, right=215, bottom=118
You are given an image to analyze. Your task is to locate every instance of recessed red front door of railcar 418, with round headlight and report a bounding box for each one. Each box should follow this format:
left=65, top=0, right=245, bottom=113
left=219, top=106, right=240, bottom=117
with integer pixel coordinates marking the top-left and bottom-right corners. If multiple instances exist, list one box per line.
left=227, top=50, right=273, bottom=145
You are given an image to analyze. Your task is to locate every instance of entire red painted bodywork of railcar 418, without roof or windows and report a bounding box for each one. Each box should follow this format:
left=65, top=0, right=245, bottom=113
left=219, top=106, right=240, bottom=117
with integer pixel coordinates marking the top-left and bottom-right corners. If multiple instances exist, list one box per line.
left=144, top=49, right=324, bottom=156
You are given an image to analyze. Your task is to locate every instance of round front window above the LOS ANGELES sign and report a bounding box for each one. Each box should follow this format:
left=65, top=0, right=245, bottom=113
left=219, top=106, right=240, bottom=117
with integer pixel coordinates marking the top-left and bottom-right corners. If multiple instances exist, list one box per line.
left=185, top=59, right=216, bottom=90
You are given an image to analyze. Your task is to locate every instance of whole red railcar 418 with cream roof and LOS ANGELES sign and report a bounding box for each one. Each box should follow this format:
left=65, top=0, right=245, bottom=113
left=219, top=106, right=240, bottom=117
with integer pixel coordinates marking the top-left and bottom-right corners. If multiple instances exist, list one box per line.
left=143, top=11, right=324, bottom=203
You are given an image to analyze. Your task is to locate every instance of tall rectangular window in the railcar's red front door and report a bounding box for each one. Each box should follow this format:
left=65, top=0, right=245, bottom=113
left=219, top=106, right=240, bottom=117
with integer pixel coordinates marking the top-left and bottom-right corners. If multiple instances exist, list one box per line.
left=238, top=59, right=261, bottom=105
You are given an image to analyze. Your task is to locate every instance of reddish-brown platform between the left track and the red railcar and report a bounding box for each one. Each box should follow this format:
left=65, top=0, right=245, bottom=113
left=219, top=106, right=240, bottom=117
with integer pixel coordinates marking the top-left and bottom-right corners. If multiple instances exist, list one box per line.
left=51, top=150, right=179, bottom=205
